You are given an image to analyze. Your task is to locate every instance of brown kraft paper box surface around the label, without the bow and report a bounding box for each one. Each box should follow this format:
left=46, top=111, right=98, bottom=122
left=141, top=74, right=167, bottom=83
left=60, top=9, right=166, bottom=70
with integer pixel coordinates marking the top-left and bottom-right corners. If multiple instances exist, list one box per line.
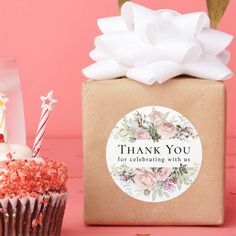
left=82, top=78, right=226, bottom=225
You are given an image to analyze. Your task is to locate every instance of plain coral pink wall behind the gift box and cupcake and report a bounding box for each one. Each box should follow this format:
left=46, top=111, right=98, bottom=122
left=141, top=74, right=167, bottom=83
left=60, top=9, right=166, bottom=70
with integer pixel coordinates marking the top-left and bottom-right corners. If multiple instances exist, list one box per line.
left=0, top=0, right=236, bottom=137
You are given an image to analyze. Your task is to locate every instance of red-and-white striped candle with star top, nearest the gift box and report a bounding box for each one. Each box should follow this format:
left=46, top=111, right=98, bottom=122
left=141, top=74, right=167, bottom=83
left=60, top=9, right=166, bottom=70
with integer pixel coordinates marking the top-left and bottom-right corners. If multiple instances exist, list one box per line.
left=33, top=91, right=57, bottom=157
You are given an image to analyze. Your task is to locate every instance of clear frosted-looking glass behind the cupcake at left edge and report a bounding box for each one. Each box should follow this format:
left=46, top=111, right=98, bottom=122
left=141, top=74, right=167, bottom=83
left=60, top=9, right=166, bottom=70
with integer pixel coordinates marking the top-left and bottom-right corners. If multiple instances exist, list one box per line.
left=0, top=57, right=26, bottom=144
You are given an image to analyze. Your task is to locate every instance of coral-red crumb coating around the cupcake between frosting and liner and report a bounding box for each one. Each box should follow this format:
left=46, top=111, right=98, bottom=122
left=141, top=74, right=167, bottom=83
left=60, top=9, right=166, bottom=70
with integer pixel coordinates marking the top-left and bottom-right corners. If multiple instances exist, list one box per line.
left=0, top=159, right=68, bottom=198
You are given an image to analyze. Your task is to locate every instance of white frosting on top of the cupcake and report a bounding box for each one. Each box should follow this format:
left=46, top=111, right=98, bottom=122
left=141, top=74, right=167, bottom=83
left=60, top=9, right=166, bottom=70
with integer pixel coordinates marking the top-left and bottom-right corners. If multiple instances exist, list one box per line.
left=0, top=143, right=44, bottom=162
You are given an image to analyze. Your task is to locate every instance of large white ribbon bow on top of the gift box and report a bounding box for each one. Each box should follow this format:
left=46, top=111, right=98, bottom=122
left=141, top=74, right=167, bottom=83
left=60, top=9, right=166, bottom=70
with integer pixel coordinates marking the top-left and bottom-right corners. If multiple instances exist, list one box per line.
left=82, top=2, right=233, bottom=84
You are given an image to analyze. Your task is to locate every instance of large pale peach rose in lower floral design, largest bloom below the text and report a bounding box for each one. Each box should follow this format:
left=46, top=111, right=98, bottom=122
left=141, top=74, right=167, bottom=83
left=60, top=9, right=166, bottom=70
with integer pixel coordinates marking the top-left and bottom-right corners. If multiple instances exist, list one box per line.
left=134, top=171, right=155, bottom=190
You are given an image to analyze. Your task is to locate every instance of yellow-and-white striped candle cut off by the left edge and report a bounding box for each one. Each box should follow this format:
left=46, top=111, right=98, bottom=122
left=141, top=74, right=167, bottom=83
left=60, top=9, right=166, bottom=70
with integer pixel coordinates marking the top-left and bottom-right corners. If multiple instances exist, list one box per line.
left=0, top=93, right=9, bottom=142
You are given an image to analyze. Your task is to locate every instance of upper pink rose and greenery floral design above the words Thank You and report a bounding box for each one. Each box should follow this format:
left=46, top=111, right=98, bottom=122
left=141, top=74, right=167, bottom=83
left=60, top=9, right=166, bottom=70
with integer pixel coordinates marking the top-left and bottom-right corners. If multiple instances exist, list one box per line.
left=114, top=107, right=197, bottom=142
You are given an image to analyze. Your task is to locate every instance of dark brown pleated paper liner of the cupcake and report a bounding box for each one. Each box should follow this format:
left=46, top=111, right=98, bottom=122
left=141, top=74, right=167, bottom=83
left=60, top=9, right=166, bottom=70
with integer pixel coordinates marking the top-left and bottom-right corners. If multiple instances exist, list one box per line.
left=0, top=193, right=67, bottom=236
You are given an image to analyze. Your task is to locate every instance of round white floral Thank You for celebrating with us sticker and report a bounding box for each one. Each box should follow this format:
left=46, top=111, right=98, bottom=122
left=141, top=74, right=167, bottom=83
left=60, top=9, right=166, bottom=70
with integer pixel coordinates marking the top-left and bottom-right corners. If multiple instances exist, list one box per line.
left=106, top=106, right=202, bottom=202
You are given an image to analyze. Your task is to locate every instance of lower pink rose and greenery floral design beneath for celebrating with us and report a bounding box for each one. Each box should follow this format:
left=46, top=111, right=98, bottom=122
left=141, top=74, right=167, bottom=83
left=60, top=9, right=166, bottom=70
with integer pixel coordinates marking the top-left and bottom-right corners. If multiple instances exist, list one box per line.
left=111, top=164, right=199, bottom=201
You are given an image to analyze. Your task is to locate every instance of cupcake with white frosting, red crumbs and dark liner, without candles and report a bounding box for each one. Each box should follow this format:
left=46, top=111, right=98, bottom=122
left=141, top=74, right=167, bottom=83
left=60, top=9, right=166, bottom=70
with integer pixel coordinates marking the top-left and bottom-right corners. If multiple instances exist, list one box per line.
left=0, top=135, right=68, bottom=236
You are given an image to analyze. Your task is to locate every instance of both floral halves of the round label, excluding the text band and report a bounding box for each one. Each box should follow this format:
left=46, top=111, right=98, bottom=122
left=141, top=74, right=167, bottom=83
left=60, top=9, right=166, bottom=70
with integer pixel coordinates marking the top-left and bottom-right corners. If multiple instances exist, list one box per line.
left=110, top=107, right=201, bottom=202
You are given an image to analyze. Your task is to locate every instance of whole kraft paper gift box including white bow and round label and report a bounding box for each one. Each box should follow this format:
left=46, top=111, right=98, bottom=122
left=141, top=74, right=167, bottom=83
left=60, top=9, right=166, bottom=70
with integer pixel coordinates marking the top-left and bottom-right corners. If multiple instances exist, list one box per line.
left=82, top=0, right=232, bottom=225
